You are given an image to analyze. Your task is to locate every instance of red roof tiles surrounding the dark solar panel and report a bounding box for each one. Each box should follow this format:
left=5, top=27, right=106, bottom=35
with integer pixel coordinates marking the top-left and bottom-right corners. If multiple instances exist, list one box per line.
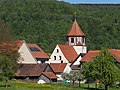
left=28, top=44, right=49, bottom=58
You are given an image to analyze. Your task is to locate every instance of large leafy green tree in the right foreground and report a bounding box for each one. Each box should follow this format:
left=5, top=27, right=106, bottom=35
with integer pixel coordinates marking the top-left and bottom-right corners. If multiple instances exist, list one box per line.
left=85, top=50, right=120, bottom=90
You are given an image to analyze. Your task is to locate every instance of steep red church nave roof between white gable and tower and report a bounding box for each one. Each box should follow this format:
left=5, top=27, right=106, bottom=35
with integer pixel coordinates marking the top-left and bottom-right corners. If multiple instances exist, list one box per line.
left=58, top=45, right=78, bottom=62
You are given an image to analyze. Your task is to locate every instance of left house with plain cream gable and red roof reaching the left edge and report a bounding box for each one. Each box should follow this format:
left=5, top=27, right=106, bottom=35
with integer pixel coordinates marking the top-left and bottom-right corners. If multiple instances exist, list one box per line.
left=0, top=40, right=37, bottom=64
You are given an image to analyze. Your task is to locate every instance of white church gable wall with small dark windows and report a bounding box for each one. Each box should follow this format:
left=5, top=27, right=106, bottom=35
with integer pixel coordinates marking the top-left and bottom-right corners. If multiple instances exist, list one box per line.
left=49, top=45, right=68, bottom=63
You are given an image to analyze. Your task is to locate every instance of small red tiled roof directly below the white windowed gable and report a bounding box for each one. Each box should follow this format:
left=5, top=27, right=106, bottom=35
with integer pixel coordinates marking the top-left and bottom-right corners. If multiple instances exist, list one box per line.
left=50, top=63, right=67, bottom=72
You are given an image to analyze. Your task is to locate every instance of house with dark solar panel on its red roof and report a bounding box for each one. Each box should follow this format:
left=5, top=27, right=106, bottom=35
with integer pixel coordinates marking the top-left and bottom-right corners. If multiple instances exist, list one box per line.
left=27, top=44, right=49, bottom=63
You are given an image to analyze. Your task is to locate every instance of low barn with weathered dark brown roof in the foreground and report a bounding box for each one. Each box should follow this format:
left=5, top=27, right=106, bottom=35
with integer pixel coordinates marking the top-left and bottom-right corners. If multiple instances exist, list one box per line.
left=15, top=64, right=58, bottom=83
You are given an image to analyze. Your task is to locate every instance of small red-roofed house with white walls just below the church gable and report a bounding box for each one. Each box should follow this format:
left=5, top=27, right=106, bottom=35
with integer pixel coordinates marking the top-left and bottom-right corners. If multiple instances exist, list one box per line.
left=50, top=63, right=71, bottom=80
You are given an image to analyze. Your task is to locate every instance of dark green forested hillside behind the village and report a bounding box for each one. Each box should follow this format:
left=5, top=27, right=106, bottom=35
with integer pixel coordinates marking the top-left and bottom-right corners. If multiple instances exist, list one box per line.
left=0, top=0, right=120, bottom=52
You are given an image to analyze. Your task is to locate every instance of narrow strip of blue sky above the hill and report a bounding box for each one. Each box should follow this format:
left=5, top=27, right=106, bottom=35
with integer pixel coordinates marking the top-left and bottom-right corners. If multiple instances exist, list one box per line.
left=62, top=0, right=120, bottom=4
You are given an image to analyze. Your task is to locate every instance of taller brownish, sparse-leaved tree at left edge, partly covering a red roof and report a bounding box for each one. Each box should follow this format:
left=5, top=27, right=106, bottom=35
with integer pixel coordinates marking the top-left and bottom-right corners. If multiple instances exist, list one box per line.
left=0, top=21, right=19, bottom=77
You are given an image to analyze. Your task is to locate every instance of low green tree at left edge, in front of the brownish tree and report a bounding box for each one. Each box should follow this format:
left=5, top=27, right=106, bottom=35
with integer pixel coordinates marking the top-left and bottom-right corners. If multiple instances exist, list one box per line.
left=0, top=56, right=15, bottom=88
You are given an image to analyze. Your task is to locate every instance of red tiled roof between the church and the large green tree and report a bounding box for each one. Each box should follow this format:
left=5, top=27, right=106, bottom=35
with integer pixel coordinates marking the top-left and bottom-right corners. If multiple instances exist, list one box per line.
left=80, top=50, right=100, bottom=62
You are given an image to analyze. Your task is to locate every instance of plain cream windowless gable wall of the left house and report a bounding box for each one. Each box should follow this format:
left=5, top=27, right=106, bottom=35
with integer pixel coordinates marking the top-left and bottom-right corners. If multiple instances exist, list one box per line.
left=18, top=43, right=37, bottom=64
